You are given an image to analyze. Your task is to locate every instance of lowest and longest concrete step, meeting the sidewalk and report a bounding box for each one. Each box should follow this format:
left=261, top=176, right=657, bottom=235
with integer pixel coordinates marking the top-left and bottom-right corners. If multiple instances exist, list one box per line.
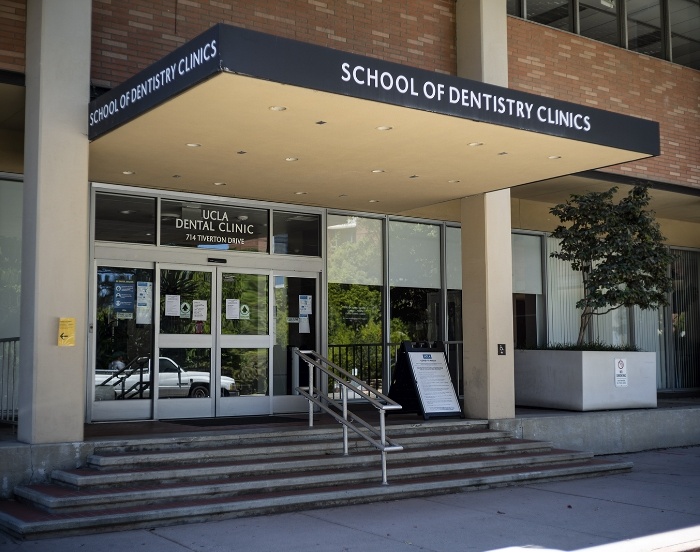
left=0, top=460, right=631, bottom=538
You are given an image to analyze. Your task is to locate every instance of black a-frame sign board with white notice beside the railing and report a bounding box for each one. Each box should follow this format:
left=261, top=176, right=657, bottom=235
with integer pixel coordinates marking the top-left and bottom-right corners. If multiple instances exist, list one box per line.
left=389, top=341, right=462, bottom=420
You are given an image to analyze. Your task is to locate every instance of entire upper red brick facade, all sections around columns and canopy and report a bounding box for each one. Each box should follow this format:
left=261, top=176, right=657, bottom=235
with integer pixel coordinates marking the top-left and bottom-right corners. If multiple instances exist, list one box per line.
left=0, top=0, right=700, bottom=188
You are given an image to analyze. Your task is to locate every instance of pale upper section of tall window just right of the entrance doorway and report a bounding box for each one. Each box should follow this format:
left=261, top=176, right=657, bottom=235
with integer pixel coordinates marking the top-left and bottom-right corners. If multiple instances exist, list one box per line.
left=326, top=215, right=384, bottom=286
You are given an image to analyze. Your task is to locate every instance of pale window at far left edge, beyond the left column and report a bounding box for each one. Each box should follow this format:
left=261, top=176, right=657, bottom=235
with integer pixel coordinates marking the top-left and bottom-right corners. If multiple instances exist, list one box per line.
left=0, top=180, right=22, bottom=339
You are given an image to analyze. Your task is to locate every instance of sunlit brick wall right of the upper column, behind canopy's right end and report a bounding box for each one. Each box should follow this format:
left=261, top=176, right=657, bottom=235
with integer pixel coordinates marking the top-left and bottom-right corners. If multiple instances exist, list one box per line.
left=508, top=17, right=700, bottom=188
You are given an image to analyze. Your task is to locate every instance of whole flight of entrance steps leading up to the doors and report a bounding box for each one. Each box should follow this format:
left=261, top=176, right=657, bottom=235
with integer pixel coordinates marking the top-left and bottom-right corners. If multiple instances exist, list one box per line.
left=0, top=419, right=631, bottom=539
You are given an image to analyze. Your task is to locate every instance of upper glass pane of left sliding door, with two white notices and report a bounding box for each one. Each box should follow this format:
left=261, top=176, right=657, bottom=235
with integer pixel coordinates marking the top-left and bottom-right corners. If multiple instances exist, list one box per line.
left=160, top=269, right=211, bottom=334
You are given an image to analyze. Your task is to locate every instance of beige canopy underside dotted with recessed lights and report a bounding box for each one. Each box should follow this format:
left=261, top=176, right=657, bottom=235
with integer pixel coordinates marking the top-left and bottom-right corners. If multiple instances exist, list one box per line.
left=90, top=73, right=648, bottom=221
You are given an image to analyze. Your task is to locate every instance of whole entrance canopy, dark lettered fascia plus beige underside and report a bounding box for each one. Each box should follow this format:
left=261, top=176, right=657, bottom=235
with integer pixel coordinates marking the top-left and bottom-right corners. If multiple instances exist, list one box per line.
left=0, top=25, right=659, bottom=221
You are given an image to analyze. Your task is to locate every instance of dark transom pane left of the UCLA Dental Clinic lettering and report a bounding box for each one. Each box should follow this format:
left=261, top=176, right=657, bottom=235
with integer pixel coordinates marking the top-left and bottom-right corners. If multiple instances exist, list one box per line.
left=95, top=192, right=156, bottom=245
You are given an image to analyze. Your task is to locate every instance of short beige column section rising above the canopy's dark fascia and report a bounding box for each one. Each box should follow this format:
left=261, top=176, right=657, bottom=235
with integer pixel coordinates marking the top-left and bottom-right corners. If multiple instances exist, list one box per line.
left=456, top=0, right=508, bottom=87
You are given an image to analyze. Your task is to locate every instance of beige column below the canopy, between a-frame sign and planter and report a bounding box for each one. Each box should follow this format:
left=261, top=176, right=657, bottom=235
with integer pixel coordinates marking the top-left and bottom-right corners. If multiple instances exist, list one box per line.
left=462, top=190, right=515, bottom=420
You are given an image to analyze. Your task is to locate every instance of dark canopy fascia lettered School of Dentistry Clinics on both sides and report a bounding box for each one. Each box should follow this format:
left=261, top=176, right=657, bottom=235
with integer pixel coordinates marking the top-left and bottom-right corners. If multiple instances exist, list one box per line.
left=90, top=25, right=660, bottom=155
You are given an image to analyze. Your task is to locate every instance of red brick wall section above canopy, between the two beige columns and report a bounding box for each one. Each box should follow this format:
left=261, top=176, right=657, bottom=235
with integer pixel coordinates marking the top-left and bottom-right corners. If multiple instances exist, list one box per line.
left=87, top=0, right=456, bottom=87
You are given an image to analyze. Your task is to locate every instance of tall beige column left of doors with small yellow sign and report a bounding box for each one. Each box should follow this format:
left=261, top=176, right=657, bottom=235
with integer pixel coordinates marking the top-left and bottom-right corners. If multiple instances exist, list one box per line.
left=17, top=0, right=92, bottom=444
